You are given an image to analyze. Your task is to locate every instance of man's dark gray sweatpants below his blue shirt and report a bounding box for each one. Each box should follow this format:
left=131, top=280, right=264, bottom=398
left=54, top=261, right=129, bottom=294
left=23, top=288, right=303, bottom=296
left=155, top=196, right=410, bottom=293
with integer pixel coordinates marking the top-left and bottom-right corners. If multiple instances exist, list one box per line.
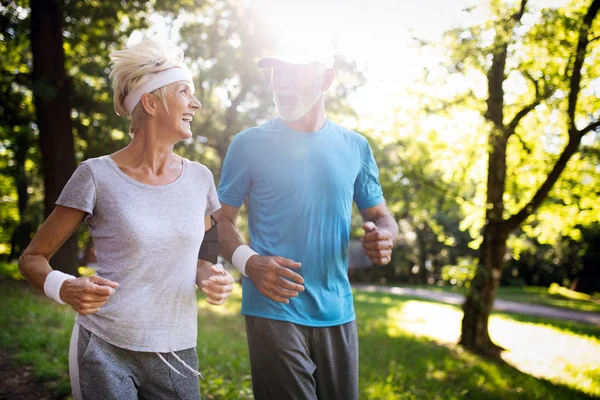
left=246, top=316, right=358, bottom=400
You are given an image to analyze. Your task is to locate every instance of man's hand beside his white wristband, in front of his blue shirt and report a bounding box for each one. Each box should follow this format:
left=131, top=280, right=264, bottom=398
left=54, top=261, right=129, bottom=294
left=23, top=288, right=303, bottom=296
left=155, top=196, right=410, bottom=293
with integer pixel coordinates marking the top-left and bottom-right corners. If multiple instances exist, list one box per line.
left=246, top=255, right=304, bottom=304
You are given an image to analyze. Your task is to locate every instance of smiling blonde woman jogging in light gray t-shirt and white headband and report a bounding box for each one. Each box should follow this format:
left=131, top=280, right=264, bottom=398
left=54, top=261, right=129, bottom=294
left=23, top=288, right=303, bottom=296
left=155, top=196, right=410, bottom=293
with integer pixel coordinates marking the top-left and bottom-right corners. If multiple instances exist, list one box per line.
left=19, top=40, right=233, bottom=399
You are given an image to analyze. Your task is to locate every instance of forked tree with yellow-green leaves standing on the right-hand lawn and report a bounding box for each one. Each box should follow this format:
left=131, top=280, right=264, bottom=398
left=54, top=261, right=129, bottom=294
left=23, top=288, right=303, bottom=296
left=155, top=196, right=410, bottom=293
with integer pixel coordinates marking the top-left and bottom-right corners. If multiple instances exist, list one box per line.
left=454, top=0, right=600, bottom=355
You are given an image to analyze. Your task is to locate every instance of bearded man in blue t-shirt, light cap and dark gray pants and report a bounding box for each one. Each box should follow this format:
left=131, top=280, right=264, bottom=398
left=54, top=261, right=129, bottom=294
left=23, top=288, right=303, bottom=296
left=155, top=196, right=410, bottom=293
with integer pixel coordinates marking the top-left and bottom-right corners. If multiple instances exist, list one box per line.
left=217, top=47, right=398, bottom=400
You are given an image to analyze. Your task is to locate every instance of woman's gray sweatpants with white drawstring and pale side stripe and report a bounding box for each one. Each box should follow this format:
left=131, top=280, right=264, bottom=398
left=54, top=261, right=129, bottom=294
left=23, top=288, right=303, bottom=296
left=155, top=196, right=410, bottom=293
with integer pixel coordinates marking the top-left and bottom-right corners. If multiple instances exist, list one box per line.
left=69, top=323, right=200, bottom=400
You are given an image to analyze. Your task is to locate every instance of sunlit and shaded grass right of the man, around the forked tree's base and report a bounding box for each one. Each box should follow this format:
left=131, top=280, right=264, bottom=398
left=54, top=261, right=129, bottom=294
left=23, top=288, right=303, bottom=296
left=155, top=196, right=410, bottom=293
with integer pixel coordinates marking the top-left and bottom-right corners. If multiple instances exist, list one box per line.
left=355, top=292, right=600, bottom=399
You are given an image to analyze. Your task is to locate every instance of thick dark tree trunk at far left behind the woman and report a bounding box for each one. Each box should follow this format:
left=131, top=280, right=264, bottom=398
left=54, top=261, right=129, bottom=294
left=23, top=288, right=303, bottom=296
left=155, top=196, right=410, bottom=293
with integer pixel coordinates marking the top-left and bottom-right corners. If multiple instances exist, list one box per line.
left=30, top=0, right=77, bottom=275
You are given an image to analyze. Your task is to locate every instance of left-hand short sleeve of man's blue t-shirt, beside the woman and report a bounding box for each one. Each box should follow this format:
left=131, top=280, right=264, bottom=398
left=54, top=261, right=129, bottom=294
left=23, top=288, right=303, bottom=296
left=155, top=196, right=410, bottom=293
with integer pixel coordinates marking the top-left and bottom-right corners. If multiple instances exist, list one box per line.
left=218, top=135, right=250, bottom=208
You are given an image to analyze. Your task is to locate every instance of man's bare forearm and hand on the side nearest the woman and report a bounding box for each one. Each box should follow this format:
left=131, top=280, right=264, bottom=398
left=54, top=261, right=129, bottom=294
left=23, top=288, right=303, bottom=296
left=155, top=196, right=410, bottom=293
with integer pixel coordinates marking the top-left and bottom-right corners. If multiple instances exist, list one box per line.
left=216, top=203, right=304, bottom=304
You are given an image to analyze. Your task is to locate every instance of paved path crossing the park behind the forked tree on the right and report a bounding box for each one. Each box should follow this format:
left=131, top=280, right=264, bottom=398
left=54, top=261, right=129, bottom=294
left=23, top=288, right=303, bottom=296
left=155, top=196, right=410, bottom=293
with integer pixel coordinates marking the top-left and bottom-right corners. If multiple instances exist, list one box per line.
left=352, top=284, right=600, bottom=326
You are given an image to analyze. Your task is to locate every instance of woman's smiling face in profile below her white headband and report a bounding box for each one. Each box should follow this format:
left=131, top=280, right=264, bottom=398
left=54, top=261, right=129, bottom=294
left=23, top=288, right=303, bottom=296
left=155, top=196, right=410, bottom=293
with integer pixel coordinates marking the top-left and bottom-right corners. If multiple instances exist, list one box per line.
left=157, top=81, right=201, bottom=140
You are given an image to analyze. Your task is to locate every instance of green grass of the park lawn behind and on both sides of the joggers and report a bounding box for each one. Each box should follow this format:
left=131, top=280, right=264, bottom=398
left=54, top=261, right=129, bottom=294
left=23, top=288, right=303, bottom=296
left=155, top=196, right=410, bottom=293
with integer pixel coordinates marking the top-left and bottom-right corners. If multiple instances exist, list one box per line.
left=0, top=260, right=600, bottom=400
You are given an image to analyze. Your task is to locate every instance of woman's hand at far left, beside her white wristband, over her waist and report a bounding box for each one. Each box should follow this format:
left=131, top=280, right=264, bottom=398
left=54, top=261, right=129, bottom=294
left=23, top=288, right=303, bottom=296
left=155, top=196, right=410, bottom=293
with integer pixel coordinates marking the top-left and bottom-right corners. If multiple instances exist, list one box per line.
left=60, top=275, right=119, bottom=315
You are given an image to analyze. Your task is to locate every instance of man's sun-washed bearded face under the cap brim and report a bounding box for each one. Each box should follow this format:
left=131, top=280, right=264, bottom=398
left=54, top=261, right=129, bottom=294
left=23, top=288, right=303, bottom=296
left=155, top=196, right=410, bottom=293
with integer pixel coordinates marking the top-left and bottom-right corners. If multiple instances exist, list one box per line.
left=271, top=63, right=324, bottom=122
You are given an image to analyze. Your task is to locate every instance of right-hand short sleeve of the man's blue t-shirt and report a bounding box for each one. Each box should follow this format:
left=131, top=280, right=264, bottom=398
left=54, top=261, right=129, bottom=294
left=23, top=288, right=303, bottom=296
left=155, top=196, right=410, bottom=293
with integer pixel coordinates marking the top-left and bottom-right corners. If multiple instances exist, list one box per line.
left=354, top=141, right=385, bottom=210
